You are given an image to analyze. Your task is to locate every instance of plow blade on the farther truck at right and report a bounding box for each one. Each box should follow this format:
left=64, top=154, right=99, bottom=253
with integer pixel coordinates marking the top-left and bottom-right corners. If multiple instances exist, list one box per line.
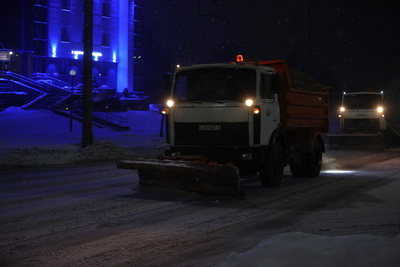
left=327, top=133, right=385, bottom=150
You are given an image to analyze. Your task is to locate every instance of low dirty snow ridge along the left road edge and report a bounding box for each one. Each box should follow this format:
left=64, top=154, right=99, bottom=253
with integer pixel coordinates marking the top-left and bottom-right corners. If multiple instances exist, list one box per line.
left=2, top=141, right=134, bottom=166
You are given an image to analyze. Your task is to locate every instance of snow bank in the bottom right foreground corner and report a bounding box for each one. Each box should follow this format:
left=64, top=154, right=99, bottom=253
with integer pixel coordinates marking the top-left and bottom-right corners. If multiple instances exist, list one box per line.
left=216, top=232, right=400, bottom=267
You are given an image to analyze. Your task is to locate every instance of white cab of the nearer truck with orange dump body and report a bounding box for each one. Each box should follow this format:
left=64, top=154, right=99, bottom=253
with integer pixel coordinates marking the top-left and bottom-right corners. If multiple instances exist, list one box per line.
left=164, top=64, right=280, bottom=151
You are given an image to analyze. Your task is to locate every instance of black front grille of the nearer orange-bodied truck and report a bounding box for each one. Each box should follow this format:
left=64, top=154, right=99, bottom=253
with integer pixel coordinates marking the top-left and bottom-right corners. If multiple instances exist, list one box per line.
left=175, top=122, right=249, bottom=147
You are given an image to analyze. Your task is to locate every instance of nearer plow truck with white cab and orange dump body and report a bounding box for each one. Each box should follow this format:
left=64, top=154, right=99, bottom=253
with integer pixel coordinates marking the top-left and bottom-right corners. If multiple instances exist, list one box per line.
left=117, top=55, right=329, bottom=196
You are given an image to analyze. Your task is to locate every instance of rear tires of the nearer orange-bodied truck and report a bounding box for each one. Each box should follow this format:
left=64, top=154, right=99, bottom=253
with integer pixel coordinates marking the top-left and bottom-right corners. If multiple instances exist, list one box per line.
left=290, top=140, right=322, bottom=178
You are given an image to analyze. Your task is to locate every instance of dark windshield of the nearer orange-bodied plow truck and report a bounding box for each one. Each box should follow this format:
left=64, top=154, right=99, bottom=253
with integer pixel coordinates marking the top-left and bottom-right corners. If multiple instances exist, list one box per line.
left=174, top=68, right=256, bottom=101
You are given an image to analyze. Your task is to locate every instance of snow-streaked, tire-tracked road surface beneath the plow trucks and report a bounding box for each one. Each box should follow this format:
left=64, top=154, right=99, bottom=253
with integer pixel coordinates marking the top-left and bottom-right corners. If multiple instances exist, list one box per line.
left=0, top=149, right=400, bottom=266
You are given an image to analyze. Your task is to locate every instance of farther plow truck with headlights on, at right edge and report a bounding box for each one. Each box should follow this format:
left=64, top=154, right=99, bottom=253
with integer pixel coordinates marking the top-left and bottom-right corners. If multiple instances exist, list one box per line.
left=327, top=86, right=400, bottom=149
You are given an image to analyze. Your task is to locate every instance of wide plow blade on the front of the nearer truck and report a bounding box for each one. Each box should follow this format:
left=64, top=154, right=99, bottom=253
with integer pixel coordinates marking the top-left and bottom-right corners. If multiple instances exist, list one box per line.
left=117, top=157, right=243, bottom=197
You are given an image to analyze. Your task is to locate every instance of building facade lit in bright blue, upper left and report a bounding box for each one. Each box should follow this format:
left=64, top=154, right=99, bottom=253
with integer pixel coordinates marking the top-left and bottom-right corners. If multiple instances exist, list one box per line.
left=0, top=0, right=144, bottom=91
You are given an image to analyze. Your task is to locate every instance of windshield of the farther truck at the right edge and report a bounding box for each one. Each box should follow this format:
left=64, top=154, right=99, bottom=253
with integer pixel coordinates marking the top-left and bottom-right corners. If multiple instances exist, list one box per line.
left=343, top=94, right=382, bottom=109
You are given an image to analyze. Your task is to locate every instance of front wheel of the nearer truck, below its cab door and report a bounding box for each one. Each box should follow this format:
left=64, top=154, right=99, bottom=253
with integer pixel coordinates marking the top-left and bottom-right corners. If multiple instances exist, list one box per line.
left=260, top=142, right=285, bottom=187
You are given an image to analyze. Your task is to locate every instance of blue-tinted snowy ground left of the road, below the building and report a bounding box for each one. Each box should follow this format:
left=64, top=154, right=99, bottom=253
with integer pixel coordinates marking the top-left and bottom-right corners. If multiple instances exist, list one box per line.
left=0, top=107, right=166, bottom=167
